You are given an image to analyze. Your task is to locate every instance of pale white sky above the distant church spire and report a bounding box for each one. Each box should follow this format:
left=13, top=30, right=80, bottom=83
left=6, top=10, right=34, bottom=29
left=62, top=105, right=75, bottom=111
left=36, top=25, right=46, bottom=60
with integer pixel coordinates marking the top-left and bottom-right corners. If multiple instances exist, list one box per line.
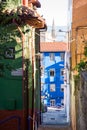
left=38, top=0, right=68, bottom=26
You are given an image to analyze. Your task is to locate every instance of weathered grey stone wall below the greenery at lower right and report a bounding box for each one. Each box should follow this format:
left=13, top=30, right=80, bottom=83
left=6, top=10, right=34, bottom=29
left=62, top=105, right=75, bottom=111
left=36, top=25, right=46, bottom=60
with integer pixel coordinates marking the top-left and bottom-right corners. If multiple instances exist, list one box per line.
left=76, top=71, right=87, bottom=130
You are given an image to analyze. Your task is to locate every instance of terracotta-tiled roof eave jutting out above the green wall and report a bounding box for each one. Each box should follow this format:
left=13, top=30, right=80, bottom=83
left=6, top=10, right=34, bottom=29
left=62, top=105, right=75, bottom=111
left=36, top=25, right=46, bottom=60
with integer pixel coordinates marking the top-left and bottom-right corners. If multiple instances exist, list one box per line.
left=0, top=6, right=46, bottom=29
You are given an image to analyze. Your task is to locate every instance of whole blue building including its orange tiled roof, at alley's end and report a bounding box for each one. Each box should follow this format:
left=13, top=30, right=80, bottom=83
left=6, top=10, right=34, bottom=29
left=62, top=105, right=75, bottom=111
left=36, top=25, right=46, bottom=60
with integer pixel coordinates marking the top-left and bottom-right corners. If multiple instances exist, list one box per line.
left=40, top=42, right=67, bottom=107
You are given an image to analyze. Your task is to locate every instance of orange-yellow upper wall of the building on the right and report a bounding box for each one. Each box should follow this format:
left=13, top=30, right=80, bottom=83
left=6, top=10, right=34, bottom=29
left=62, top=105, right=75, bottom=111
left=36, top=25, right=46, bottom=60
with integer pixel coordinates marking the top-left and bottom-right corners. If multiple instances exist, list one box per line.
left=71, top=0, right=87, bottom=69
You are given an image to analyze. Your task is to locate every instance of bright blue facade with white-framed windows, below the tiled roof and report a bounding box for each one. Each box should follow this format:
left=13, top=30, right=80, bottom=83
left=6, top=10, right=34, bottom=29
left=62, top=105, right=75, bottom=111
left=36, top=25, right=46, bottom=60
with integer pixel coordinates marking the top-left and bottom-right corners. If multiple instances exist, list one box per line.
left=41, top=52, right=65, bottom=107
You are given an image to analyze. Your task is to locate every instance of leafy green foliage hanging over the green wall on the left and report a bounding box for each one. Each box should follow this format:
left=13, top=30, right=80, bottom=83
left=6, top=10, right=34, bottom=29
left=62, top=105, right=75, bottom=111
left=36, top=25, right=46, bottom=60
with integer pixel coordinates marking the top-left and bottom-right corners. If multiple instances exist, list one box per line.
left=0, top=0, right=30, bottom=76
